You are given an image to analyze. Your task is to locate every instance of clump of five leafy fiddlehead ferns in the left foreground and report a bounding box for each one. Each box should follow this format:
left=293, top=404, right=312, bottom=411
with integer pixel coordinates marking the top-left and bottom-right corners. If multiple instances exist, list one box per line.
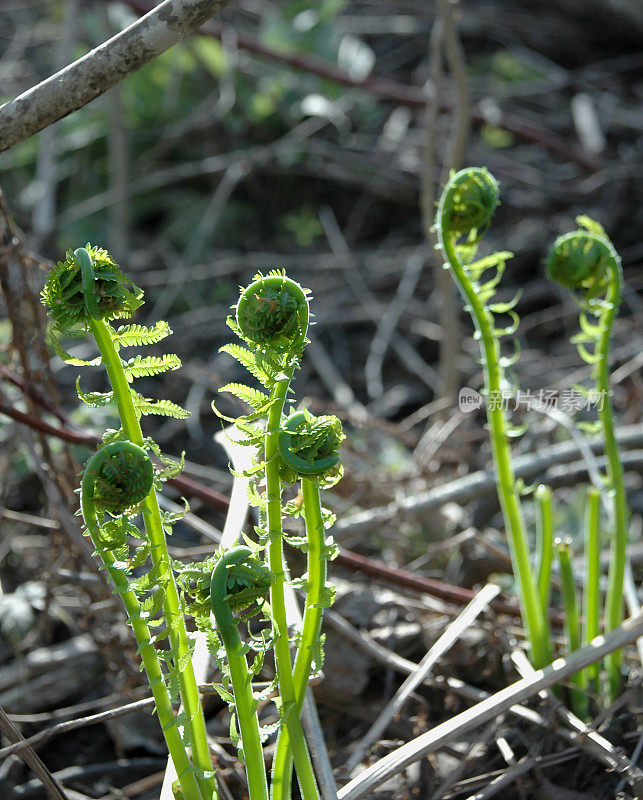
left=42, top=252, right=344, bottom=800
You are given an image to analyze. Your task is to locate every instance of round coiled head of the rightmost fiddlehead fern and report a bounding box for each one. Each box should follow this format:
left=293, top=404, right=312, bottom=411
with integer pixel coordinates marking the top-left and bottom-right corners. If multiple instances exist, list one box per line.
left=547, top=223, right=620, bottom=300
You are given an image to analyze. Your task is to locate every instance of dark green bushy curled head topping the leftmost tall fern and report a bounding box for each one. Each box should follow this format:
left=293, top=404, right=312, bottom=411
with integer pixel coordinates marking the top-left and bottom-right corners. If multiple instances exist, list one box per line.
left=42, top=244, right=143, bottom=330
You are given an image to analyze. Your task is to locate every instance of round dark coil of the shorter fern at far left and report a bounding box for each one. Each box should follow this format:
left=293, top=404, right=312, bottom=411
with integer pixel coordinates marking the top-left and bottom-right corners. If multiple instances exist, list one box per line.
left=82, top=442, right=154, bottom=516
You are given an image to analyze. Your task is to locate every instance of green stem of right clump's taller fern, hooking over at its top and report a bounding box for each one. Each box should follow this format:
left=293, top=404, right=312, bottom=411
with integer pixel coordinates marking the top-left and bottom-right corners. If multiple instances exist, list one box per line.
left=436, top=170, right=551, bottom=669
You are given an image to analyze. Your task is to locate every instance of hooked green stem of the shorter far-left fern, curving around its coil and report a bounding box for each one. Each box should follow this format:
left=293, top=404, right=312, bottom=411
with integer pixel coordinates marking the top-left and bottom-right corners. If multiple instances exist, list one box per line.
left=80, top=442, right=204, bottom=800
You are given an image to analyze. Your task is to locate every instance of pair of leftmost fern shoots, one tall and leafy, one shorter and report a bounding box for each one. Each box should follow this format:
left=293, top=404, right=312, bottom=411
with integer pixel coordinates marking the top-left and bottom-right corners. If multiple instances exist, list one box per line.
left=43, top=245, right=217, bottom=800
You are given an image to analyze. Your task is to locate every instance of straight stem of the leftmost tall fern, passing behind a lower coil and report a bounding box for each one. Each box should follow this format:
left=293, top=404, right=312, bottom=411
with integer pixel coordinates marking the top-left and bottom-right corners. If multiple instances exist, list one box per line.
left=89, top=318, right=218, bottom=800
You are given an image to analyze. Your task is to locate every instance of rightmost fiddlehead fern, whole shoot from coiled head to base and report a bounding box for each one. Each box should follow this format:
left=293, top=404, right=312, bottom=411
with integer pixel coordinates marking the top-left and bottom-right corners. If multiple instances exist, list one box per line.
left=547, top=217, right=629, bottom=699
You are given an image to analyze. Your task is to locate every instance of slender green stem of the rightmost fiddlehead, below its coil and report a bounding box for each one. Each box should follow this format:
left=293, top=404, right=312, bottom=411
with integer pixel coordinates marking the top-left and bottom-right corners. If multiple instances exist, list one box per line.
left=594, top=266, right=628, bottom=700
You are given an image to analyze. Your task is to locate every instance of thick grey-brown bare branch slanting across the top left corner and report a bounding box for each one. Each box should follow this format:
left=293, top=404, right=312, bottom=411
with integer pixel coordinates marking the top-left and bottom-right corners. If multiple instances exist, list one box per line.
left=0, top=0, right=235, bottom=152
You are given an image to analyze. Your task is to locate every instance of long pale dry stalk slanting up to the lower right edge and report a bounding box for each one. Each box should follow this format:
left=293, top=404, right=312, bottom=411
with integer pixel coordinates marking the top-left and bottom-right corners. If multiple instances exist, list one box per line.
left=338, top=611, right=643, bottom=800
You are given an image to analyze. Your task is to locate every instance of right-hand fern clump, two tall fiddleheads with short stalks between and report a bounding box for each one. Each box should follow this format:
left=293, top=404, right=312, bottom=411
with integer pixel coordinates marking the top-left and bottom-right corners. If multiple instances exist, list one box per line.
left=435, top=168, right=629, bottom=717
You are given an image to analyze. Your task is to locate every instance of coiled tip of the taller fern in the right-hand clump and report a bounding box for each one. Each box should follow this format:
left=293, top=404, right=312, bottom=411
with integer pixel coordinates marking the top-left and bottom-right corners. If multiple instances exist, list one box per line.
left=438, top=167, right=500, bottom=237
